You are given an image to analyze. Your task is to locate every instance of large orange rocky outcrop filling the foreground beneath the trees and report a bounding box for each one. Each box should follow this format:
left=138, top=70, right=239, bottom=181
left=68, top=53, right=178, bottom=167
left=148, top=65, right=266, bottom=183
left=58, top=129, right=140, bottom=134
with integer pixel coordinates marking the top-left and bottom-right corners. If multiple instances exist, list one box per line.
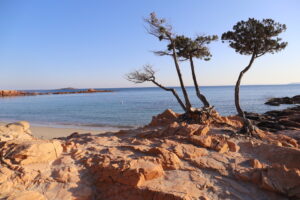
left=0, top=110, right=300, bottom=200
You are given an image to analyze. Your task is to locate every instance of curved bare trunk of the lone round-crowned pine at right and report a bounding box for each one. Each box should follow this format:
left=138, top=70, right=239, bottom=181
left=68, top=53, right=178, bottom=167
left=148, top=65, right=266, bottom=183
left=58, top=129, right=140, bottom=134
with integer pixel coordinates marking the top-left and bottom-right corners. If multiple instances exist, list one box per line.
left=234, top=53, right=255, bottom=119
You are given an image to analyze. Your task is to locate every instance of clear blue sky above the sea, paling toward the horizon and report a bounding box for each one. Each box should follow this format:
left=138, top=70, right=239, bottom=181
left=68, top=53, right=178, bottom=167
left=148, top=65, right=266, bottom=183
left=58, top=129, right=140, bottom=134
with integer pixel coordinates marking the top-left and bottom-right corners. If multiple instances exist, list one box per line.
left=0, top=0, right=300, bottom=89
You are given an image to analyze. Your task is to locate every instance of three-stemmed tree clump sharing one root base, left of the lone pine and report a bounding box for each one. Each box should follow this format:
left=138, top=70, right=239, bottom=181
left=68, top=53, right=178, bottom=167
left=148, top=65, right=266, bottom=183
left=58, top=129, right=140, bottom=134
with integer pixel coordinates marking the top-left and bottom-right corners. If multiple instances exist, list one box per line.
left=126, top=13, right=217, bottom=123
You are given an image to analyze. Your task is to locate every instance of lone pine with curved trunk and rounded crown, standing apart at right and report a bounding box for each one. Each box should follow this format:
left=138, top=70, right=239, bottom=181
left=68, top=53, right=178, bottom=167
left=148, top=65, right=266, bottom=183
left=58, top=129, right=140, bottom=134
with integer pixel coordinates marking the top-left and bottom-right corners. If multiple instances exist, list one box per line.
left=222, top=18, right=287, bottom=134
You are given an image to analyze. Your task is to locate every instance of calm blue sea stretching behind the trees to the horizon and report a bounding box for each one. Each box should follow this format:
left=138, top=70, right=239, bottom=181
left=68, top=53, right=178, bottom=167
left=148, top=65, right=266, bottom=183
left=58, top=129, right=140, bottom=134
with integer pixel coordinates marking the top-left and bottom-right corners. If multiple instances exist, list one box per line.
left=0, top=84, right=300, bottom=130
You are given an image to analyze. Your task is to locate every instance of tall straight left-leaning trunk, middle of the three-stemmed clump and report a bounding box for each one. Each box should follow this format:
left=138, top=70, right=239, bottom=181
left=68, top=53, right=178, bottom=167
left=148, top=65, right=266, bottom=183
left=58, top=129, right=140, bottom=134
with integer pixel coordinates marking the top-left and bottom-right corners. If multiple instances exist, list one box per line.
left=170, top=38, right=192, bottom=112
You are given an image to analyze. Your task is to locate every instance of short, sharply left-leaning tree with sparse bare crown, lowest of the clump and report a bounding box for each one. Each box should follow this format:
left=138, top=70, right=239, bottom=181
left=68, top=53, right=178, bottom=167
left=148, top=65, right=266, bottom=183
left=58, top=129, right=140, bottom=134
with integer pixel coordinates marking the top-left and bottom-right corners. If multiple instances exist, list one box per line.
left=126, top=65, right=186, bottom=111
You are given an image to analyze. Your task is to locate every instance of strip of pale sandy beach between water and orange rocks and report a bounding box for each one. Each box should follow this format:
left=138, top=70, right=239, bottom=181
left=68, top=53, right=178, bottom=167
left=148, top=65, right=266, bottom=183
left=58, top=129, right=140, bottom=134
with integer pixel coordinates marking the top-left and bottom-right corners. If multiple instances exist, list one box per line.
left=0, top=122, right=112, bottom=139
